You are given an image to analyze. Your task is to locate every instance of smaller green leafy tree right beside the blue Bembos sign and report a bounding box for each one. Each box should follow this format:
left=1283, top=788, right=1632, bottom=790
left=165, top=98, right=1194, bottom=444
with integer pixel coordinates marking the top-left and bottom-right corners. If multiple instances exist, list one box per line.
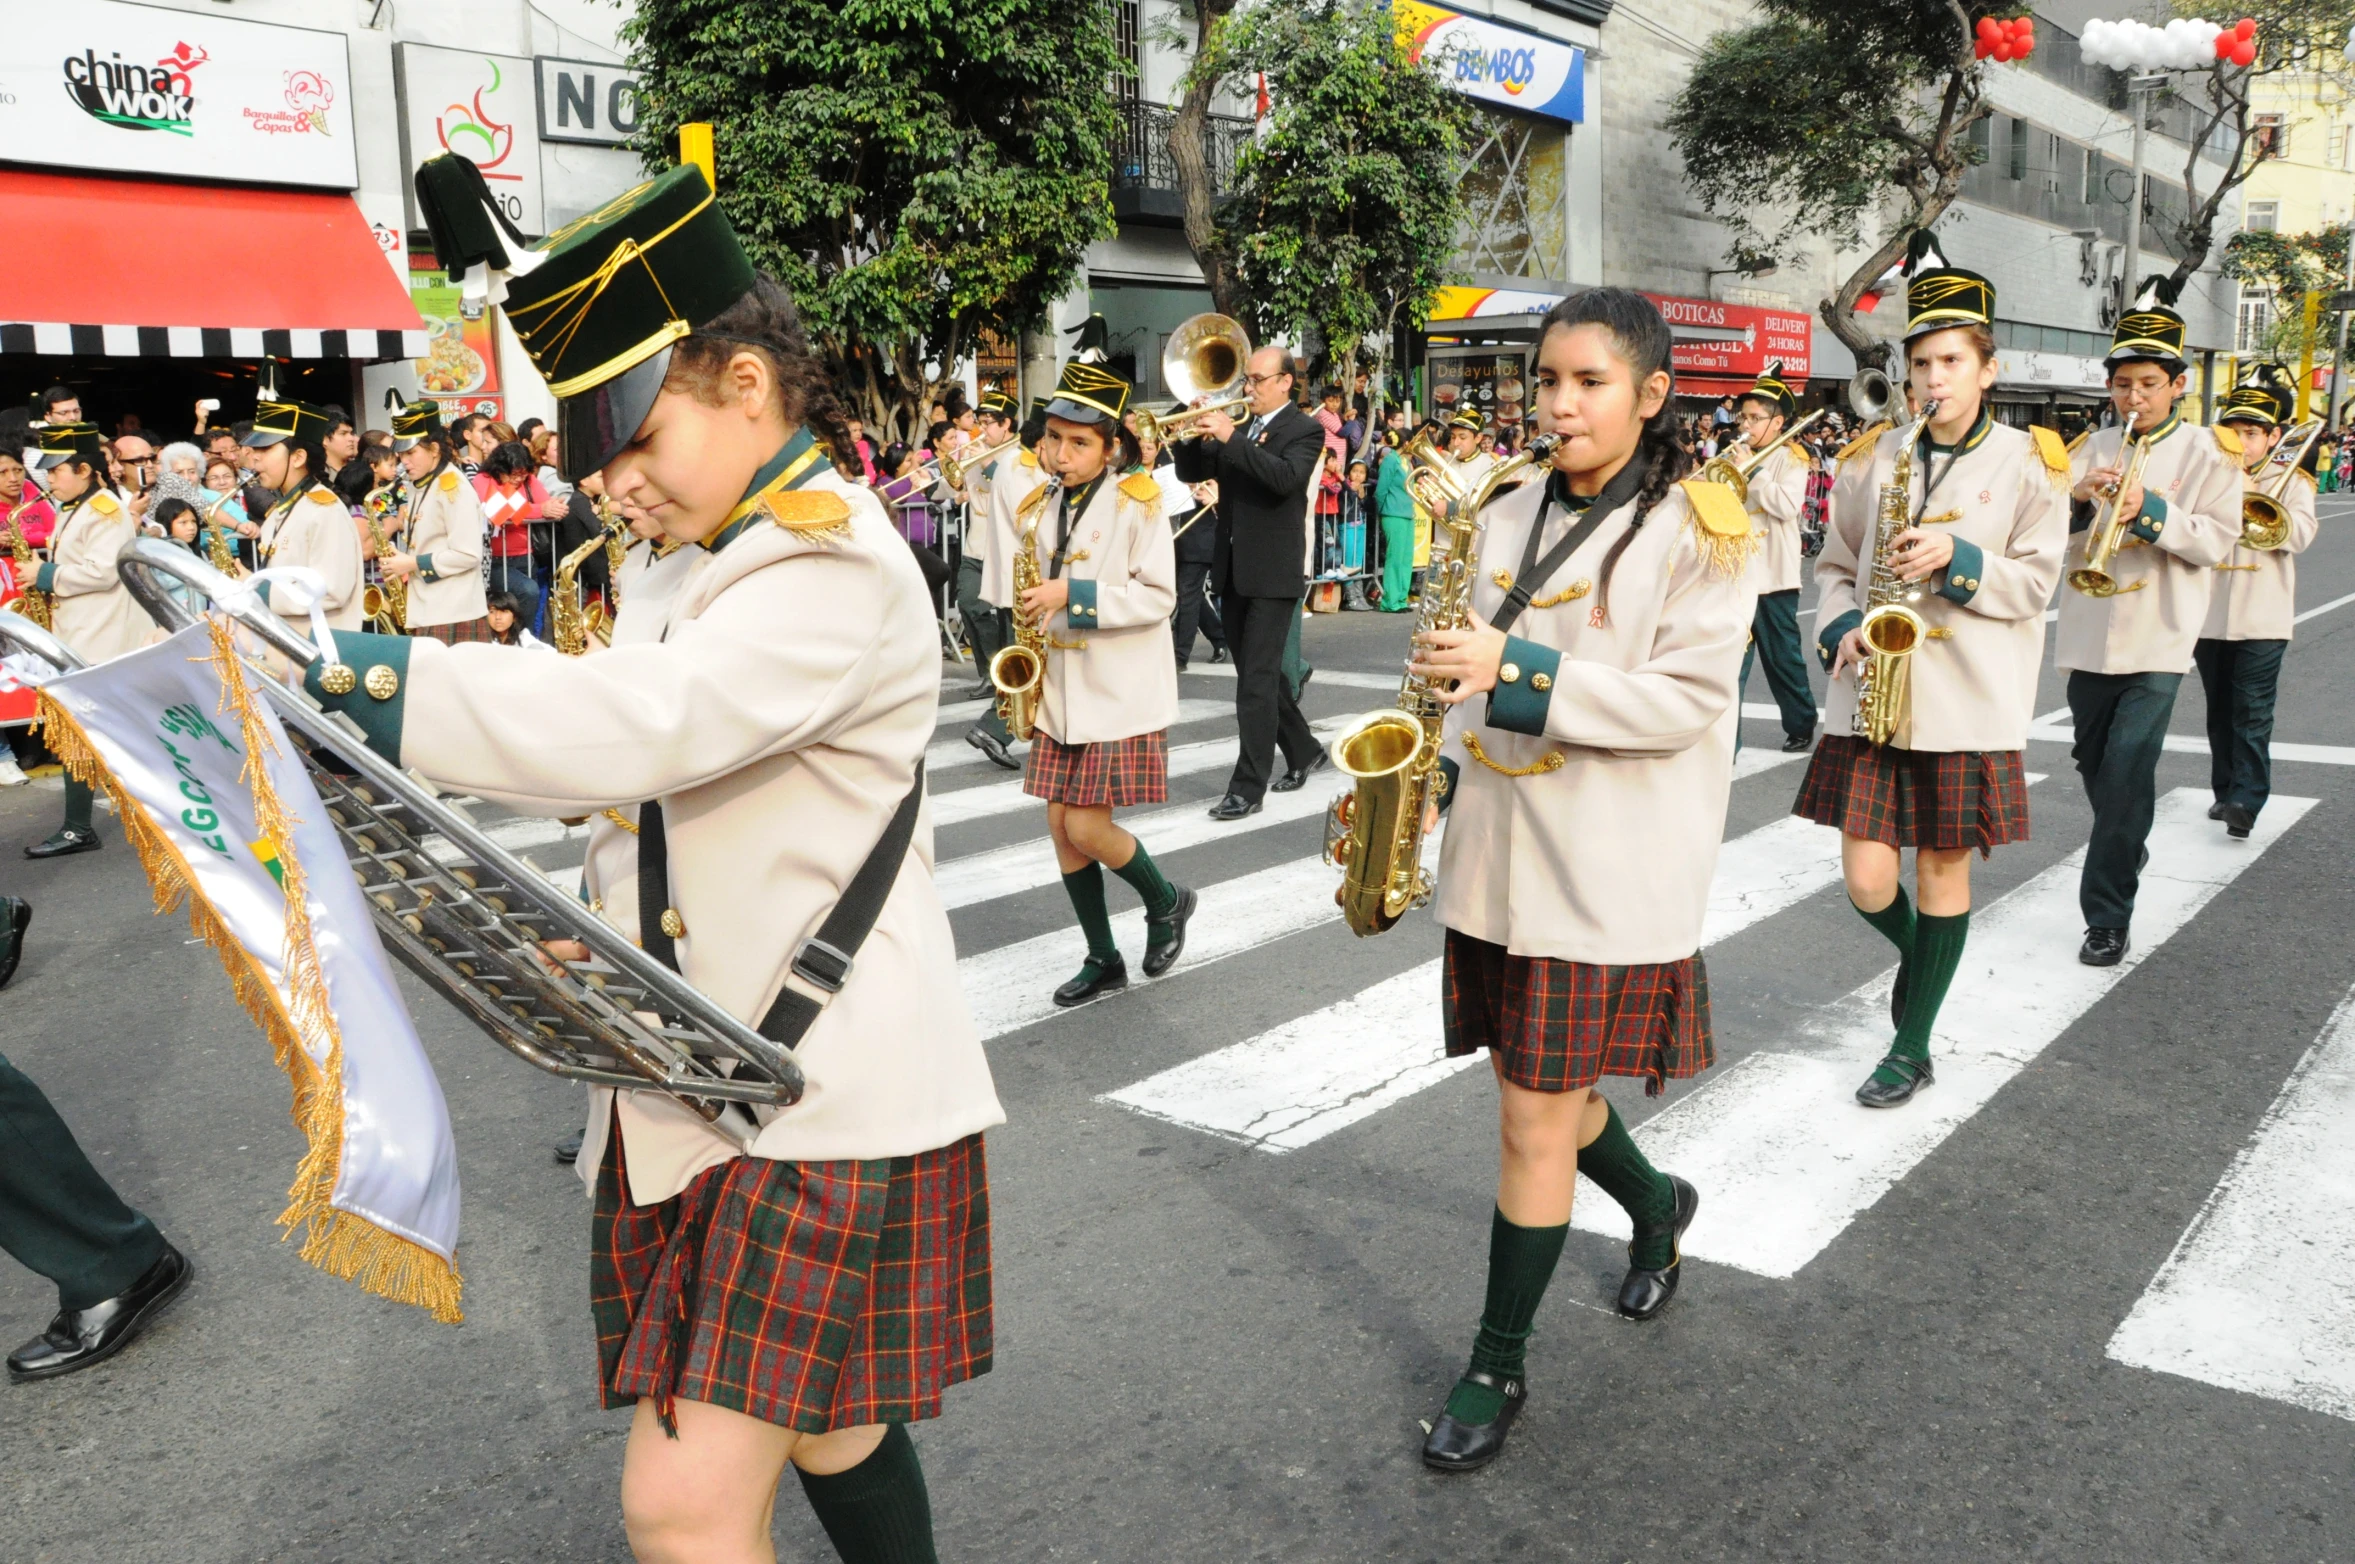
left=1194, top=0, right=1472, bottom=428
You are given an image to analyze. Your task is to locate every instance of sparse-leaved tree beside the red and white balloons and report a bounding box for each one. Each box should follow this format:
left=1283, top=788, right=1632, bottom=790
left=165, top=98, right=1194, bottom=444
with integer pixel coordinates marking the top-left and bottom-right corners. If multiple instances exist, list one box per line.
left=1667, top=0, right=2023, bottom=363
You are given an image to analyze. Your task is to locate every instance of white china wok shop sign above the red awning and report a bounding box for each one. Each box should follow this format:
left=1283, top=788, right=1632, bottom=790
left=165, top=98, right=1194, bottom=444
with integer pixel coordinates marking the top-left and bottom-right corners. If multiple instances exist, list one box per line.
left=0, top=0, right=360, bottom=191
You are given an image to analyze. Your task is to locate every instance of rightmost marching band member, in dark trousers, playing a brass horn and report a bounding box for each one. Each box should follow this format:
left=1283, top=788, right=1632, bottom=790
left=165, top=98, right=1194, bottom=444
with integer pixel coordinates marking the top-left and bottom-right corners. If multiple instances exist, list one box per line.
left=2193, top=363, right=2320, bottom=839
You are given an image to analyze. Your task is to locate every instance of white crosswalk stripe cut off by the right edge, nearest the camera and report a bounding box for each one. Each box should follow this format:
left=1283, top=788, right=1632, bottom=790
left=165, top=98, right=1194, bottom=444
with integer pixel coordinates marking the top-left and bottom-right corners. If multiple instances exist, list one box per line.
left=2110, top=984, right=2355, bottom=1418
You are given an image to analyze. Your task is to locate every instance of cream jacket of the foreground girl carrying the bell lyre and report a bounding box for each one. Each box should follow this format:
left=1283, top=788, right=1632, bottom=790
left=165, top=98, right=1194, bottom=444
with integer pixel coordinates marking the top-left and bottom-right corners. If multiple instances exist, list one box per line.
left=308, top=469, right=1006, bottom=1204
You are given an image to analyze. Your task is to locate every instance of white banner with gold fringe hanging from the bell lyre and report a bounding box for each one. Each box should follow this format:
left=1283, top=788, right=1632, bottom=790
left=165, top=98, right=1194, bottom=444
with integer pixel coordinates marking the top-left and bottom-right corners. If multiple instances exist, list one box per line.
left=42, top=624, right=459, bottom=1321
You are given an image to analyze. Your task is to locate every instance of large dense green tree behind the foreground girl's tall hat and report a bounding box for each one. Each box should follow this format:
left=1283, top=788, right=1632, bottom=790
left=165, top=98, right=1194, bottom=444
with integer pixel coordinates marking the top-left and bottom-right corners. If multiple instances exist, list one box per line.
left=622, top=0, right=1123, bottom=438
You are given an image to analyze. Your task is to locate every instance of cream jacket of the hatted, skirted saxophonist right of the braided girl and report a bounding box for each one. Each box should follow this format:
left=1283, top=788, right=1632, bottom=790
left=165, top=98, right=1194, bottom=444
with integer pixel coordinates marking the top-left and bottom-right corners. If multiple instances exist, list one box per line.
left=1816, top=415, right=2068, bottom=751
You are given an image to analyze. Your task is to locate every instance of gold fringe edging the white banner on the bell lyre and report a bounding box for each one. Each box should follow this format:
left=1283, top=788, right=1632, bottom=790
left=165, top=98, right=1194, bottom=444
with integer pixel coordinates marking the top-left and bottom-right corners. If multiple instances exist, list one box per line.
left=35, top=645, right=464, bottom=1324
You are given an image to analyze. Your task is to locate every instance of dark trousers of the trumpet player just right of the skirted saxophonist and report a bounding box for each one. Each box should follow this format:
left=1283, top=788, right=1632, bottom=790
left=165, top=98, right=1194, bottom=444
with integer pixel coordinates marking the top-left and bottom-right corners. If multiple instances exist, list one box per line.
left=2068, top=671, right=2183, bottom=928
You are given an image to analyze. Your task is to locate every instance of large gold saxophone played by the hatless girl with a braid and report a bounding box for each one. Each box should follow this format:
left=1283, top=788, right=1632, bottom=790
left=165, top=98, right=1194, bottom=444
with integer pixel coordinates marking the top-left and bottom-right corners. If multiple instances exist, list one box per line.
left=1324, top=433, right=1561, bottom=937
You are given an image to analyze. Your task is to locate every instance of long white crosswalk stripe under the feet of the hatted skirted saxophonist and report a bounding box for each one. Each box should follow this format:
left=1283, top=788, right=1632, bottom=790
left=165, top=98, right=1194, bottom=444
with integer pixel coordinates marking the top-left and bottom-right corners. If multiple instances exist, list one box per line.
left=1573, top=787, right=2315, bottom=1277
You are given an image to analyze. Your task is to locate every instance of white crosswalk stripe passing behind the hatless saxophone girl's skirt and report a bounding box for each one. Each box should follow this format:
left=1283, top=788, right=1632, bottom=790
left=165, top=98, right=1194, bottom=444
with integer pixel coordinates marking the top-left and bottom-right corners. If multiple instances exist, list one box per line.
left=1104, top=782, right=2044, bottom=1152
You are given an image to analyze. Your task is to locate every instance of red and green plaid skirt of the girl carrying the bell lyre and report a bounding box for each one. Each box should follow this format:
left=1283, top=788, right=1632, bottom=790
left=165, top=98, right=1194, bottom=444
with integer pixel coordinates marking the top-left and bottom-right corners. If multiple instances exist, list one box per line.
left=589, top=1128, right=994, bottom=1434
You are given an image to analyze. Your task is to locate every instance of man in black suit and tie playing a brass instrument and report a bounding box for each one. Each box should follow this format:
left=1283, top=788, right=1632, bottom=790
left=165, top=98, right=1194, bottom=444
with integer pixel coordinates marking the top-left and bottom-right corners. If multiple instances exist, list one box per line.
left=1175, top=349, right=1326, bottom=820
